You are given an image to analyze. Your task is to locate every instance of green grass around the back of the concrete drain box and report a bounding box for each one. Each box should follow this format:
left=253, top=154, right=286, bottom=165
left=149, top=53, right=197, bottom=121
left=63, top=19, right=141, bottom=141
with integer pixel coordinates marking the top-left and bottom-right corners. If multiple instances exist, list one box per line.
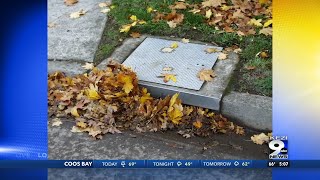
left=97, top=0, right=272, bottom=96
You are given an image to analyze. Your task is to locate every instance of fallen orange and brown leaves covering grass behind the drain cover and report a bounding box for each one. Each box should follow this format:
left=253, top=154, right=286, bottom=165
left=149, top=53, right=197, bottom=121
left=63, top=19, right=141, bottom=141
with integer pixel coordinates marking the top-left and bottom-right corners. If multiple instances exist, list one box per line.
left=150, top=0, right=272, bottom=36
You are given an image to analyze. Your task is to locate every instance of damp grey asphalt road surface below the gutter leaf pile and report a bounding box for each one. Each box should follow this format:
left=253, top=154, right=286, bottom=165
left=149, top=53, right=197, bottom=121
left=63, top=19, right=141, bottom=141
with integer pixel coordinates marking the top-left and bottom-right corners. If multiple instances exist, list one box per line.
left=48, top=120, right=271, bottom=180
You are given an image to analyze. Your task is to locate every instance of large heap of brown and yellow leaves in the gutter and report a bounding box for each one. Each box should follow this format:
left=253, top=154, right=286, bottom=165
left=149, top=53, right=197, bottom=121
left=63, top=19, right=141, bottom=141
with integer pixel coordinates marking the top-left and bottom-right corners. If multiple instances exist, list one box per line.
left=48, top=62, right=244, bottom=139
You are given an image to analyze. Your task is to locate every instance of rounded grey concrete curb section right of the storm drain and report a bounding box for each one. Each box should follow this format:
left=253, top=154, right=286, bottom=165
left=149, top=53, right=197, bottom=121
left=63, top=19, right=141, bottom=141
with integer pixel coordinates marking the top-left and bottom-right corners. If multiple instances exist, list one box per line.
left=221, top=91, right=272, bottom=131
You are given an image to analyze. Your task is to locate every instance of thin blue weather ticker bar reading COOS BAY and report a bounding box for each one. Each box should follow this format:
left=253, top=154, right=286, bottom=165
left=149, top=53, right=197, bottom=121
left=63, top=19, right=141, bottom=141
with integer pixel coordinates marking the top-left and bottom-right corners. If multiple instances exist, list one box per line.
left=0, top=160, right=320, bottom=169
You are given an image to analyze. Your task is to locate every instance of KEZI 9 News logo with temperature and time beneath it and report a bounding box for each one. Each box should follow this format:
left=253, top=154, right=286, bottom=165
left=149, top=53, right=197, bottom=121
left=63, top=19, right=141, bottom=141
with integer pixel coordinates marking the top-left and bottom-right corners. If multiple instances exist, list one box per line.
left=268, top=136, right=290, bottom=167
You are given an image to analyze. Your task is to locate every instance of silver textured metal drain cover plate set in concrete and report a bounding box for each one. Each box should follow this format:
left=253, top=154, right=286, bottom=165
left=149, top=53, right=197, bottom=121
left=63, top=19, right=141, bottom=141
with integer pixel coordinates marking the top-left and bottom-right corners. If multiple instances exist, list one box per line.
left=123, top=38, right=222, bottom=90
